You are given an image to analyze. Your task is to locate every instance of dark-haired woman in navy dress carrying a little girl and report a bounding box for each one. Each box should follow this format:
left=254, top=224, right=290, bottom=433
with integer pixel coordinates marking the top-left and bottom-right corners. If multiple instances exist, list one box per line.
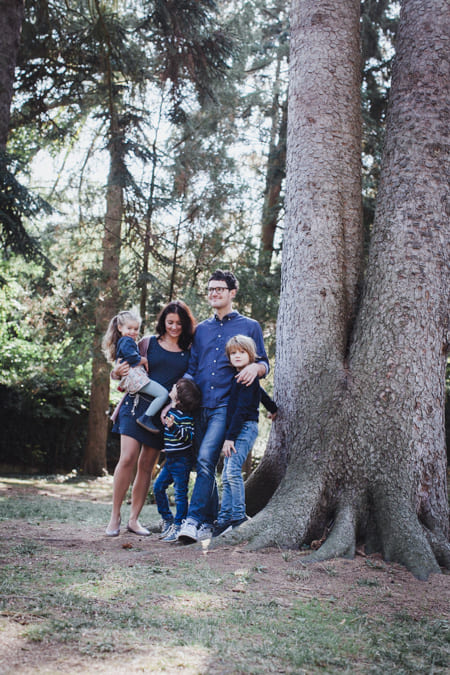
left=106, top=300, right=195, bottom=537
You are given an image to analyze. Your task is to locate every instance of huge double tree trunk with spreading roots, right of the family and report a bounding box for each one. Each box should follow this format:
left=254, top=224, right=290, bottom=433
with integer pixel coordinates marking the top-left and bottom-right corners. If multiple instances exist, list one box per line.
left=236, top=0, right=450, bottom=578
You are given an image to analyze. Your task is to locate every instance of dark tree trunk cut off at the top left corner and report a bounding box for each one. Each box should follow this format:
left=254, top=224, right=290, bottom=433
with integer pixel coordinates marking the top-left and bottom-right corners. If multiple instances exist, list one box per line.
left=0, top=0, right=23, bottom=152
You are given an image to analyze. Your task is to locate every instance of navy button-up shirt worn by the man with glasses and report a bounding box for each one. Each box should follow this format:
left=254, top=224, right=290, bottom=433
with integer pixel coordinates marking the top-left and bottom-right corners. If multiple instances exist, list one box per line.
left=186, top=311, right=269, bottom=408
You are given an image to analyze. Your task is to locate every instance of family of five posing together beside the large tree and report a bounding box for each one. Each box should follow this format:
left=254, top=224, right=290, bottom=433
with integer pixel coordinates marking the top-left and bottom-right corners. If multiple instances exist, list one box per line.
left=103, top=270, right=277, bottom=544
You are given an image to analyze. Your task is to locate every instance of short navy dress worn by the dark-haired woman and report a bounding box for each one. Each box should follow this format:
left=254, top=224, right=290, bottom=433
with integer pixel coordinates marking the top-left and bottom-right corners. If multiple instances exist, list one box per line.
left=112, top=335, right=189, bottom=450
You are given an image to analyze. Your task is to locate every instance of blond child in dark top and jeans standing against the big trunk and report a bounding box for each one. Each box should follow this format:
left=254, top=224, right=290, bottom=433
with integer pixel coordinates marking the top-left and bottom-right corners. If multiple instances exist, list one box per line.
left=213, top=335, right=278, bottom=537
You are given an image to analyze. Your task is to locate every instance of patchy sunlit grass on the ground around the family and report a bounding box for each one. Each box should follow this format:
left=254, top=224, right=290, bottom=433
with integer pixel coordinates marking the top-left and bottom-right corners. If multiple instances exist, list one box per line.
left=0, top=478, right=448, bottom=674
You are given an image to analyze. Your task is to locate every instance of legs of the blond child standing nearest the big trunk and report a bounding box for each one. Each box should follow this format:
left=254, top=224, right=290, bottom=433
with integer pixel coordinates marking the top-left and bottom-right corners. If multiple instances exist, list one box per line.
left=227, top=422, right=258, bottom=522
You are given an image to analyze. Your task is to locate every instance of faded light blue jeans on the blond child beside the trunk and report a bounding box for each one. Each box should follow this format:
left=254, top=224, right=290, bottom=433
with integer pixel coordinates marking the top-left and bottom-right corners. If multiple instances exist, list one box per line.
left=218, top=421, right=258, bottom=523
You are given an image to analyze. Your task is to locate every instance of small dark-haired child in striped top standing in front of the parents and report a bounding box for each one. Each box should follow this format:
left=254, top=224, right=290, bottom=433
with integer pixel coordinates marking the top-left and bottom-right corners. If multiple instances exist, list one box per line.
left=153, top=378, right=201, bottom=542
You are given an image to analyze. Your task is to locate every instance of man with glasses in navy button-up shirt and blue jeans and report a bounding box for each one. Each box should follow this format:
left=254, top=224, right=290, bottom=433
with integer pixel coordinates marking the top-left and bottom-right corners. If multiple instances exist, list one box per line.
left=178, top=270, right=269, bottom=544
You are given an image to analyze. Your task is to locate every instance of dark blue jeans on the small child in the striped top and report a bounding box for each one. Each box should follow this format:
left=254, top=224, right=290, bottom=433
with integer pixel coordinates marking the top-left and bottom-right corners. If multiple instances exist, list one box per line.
left=153, top=454, right=192, bottom=525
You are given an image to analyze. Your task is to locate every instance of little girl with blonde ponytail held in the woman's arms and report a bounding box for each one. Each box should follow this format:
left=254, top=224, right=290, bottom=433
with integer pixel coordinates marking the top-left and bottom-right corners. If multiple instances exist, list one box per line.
left=102, top=311, right=169, bottom=434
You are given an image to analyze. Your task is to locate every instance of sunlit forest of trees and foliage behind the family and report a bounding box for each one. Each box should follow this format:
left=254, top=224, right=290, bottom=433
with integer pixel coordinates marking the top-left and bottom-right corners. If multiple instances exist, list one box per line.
left=0, top=0, right=449, bottom=475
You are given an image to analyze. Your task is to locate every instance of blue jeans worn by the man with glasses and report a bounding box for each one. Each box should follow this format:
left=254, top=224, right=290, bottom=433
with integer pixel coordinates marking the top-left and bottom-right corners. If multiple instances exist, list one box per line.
left=187, top=406, right=227, bottom=526
